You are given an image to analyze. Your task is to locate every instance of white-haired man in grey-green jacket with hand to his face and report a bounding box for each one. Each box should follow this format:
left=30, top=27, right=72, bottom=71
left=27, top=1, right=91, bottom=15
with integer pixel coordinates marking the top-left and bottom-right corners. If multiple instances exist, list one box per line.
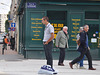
left=56, top=26, right=69, bottom=66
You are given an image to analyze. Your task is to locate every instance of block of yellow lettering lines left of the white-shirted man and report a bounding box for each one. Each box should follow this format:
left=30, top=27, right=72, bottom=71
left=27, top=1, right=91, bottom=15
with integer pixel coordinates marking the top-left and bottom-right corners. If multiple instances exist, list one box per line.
left=31, top=16, right=43, bottom=41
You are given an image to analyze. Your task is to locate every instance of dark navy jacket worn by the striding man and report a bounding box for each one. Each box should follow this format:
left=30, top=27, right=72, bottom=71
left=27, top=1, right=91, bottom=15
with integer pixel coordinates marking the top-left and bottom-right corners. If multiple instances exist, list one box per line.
left=78, top=31, right=88, bottom=52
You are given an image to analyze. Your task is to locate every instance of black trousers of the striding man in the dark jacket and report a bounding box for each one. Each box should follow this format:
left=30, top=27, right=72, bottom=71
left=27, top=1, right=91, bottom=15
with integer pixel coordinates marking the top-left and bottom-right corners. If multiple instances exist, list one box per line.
left=71, top=49, right=92, bottom=68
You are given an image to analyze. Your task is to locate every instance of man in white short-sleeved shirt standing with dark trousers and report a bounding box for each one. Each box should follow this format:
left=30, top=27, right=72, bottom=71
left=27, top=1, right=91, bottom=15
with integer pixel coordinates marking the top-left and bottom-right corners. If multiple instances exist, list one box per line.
left=42, top=16, right=54, bottom=67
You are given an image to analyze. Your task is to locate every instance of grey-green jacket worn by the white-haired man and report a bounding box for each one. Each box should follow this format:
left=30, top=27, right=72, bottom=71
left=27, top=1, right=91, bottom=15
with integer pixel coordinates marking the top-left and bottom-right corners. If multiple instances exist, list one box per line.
left=56, top=30, right=69, bottom=48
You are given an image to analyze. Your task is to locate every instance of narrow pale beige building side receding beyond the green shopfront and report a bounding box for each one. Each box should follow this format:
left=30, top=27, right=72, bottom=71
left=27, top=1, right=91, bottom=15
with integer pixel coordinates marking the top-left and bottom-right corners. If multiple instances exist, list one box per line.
left=8, top=0, right=21, bottom=51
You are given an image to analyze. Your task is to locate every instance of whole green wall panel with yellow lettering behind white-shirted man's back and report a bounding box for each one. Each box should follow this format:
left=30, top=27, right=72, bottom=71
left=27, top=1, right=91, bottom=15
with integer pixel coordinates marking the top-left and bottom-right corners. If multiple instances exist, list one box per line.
left=30, top=12, right=44, bottom=47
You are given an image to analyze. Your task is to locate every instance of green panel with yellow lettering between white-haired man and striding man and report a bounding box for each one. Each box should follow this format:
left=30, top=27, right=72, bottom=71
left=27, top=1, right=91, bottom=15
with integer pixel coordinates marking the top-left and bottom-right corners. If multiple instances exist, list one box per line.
left=69, top=13, right=82, bottom=46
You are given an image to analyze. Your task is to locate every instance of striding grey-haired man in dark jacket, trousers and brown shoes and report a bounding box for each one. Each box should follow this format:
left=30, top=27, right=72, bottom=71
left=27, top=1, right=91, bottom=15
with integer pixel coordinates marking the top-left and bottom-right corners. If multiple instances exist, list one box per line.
left=69, top=25, right=96, bottom=70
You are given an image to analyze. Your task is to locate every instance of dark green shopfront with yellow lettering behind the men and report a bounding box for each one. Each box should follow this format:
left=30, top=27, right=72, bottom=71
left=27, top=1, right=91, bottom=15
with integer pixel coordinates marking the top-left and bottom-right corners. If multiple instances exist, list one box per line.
left=11, top=0, right=100, bottom=59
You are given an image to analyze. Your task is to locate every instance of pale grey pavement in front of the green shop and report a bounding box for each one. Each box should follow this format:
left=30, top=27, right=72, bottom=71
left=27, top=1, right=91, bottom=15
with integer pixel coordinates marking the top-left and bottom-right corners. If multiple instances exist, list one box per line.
left=0, top=44, right=100, bottom=75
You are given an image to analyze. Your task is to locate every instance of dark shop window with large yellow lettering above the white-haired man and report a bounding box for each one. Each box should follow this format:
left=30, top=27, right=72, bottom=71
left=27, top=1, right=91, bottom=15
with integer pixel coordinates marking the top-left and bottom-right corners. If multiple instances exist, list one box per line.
left=47, top=11, right=67, bottom=48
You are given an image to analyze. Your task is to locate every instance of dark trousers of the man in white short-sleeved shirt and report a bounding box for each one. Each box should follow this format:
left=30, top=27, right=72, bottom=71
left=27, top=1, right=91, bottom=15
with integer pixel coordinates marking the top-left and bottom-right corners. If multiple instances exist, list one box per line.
left=44, top=41, right=53, bottom=67
